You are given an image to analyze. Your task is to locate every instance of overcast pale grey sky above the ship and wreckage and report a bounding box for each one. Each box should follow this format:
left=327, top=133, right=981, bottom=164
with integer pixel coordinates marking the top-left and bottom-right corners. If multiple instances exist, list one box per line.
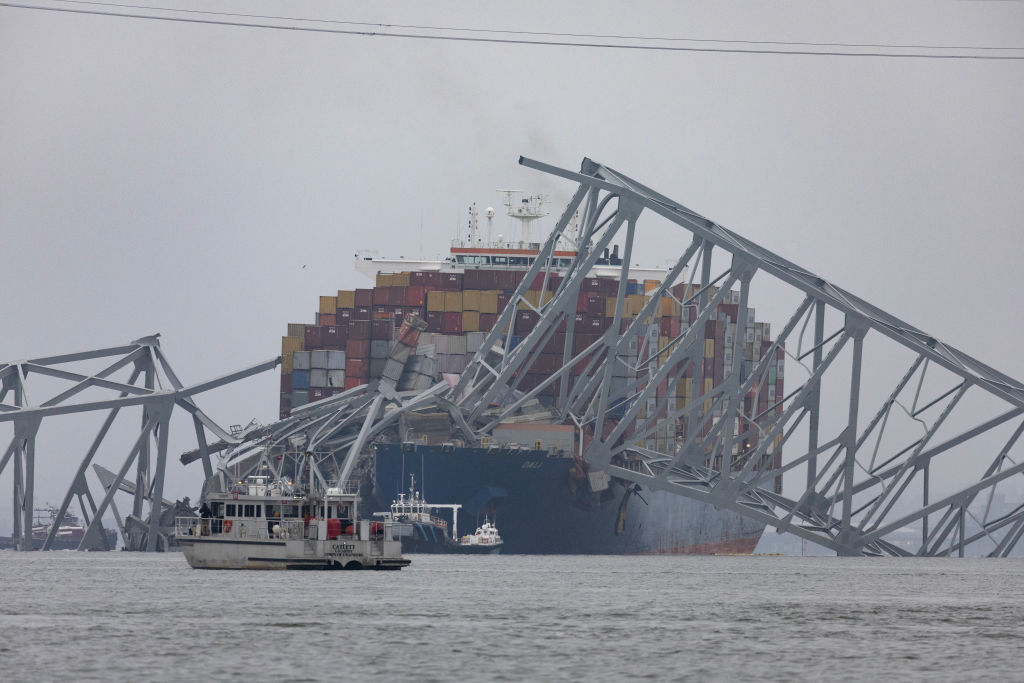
left=0, top=0, right=1024, bottom=532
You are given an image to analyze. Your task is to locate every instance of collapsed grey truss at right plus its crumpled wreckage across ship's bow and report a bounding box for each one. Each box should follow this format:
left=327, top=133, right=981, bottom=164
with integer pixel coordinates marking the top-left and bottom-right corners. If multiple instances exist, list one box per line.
left=209, top=159, right=1024, bottom=556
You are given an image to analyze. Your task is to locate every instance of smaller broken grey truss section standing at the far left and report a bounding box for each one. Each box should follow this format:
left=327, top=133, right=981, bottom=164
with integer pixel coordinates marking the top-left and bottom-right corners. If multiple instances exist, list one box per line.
left=0, top=335, right=280, bottom=551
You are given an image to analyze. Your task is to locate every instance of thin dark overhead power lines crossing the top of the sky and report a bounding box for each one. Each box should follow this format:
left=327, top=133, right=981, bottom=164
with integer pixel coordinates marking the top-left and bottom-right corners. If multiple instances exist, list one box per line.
left=0, top=0, right=1024, bottom=60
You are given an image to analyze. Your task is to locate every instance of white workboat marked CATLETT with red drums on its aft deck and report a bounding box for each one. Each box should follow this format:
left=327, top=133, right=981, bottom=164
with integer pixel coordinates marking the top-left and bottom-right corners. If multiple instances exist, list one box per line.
left=175, top=467, right=411, bottom=569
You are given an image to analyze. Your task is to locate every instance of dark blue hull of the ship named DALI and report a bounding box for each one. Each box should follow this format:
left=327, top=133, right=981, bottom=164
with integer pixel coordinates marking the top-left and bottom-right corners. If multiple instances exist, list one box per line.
left=374, top=443, right=764, bottom=555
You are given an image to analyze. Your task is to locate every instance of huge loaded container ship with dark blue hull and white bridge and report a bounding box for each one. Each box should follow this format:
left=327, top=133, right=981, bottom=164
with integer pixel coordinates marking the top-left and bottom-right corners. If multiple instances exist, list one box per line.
left=281, top=194, right=784, bottom=554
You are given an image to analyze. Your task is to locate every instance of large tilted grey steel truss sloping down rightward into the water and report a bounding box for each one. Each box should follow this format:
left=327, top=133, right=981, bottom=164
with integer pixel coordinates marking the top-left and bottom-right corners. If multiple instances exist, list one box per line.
left=444, top=158, right=1024, bottom=555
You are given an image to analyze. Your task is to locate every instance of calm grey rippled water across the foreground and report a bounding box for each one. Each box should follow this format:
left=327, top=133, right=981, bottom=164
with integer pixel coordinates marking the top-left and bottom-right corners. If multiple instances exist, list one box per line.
left=0, top=552, right=1024, bottom=682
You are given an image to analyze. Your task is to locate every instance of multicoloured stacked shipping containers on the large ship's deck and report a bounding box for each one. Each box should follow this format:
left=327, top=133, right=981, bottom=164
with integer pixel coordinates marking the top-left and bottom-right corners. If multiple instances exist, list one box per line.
left=281, top=269, right=783, bottom=485
